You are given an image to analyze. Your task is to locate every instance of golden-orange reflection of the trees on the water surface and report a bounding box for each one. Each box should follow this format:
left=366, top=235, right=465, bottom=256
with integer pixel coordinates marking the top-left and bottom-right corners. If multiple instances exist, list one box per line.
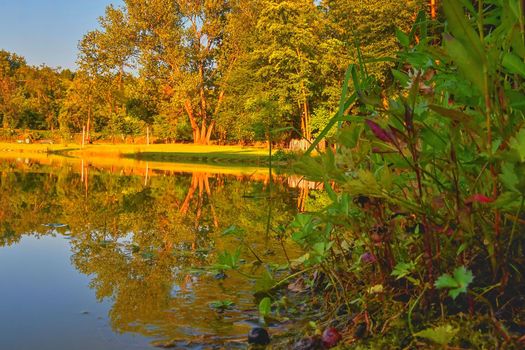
left=0, top=160, right=311, bottom=348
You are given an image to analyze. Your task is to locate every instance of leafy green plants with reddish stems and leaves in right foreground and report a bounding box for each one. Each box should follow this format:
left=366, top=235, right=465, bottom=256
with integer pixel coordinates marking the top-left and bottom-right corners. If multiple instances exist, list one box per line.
left=282, top=0, right=525, bottom=345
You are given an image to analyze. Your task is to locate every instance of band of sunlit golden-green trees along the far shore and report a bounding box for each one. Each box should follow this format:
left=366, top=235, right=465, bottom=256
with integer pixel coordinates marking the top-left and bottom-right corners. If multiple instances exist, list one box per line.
left=0, top=0, right=430, bottom=144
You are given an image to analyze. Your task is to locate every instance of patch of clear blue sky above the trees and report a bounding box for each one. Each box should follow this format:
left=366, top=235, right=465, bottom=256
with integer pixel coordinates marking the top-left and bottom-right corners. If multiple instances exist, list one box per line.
left=0, top=0, right=122, bottom=69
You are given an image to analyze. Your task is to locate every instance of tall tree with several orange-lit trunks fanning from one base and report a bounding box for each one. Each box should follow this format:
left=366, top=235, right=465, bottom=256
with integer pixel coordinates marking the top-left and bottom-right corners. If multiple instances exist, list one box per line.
left=121, top=0, right=230, bottom=144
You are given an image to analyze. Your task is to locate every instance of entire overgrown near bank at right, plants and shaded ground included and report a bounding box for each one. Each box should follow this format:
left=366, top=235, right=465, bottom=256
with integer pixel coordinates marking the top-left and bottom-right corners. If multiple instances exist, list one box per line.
left=213, top=0, right=525, bottom=349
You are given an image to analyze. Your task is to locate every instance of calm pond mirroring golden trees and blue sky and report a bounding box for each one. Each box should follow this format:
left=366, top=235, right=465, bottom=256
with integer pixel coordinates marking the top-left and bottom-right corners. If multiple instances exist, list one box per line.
left=0, top=157, right=324, bottom=350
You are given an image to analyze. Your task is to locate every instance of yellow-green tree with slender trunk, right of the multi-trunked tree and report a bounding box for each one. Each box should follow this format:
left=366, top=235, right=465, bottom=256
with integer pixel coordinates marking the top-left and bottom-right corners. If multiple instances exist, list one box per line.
left=250, top=0, right=319, bottom=139
